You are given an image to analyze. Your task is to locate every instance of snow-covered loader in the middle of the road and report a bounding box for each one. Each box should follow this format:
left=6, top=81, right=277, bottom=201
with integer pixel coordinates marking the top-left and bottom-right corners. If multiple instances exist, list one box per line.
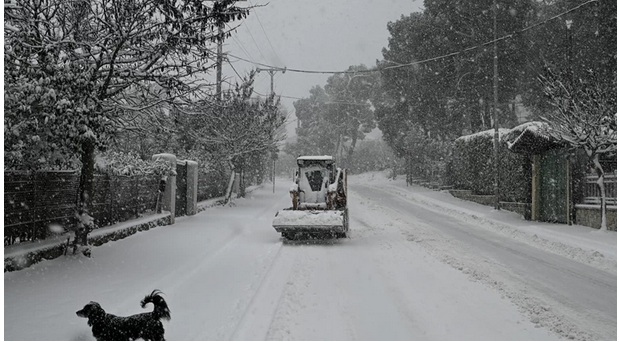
left=273, top=156, right=348, bottom=239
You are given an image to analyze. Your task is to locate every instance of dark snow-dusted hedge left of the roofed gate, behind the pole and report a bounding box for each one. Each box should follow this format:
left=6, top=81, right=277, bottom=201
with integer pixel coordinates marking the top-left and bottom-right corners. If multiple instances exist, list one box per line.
left=447, top=129, right=531, bottom=202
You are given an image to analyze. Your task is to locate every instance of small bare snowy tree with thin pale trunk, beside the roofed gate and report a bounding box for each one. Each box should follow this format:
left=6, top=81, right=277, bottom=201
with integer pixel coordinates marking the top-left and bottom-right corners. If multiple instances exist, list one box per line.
left=540, top=71, right=617, bottom=230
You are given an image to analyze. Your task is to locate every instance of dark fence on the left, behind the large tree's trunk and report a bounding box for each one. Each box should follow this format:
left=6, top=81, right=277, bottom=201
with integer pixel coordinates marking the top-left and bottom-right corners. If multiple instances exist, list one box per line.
left=4, top=171, right=159, bottom=246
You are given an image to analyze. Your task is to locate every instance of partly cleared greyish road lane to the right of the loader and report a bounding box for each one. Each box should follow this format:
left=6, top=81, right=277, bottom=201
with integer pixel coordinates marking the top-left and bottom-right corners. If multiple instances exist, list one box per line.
left=354, top=185, right=617, bottom=339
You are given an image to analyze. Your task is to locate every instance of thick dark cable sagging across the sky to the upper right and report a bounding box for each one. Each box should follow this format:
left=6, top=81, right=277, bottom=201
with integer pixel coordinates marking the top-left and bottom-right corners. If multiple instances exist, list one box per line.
left=228, top=0, right=599, bottom=74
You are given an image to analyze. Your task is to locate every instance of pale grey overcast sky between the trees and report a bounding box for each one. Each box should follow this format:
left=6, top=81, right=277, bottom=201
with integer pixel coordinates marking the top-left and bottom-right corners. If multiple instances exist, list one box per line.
left=223, top=0, right=423, bottom=132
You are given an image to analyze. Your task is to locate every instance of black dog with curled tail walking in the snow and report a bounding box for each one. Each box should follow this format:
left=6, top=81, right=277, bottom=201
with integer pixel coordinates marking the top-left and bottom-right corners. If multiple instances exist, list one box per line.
left=76, top=290, right=170, bottom=341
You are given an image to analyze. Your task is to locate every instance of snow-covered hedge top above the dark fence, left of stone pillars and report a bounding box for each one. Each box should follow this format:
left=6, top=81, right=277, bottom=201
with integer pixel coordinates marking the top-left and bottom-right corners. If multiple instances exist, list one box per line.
left=95, top=152, right=176, bottom=176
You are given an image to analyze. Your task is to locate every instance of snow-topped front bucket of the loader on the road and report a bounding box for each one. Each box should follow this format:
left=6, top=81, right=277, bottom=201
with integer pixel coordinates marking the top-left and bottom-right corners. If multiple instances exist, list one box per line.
left=273, top=209, right=348, bottom=234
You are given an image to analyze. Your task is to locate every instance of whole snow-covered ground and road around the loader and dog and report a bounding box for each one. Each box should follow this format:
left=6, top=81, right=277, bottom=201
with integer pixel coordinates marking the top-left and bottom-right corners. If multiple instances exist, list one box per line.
left=4, top=173, right=617, bottom=340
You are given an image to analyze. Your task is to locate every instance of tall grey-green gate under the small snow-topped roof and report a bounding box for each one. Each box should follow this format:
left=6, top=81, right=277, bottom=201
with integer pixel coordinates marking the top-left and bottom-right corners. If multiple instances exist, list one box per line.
left=540, top=150, right=569, bottom=223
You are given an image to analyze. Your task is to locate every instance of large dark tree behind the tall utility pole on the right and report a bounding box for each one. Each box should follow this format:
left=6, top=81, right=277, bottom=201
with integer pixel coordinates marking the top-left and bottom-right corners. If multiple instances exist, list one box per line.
left=378, top=0, right=534, bottom=139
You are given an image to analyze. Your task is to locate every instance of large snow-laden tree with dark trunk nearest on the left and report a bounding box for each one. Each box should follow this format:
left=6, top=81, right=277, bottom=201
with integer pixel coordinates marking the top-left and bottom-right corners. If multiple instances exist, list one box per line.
left=4, top=0, right=249, bottom=248
